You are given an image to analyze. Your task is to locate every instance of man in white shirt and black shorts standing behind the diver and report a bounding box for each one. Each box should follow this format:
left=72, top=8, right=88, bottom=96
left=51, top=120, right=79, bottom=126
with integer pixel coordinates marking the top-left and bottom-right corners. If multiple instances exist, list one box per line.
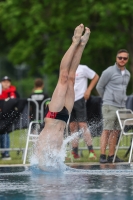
left=70, top=65, right=99, bottom=159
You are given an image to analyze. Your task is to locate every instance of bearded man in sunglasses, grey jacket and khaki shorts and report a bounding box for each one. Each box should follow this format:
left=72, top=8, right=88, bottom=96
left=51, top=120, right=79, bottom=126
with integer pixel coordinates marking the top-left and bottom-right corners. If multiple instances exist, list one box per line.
left=96, top=49, right=130, bottom=163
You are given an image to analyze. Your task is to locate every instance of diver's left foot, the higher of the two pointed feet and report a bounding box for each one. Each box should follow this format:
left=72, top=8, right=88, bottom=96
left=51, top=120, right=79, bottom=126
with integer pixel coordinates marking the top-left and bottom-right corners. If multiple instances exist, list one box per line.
left=72, top=24, right=84, bottom=45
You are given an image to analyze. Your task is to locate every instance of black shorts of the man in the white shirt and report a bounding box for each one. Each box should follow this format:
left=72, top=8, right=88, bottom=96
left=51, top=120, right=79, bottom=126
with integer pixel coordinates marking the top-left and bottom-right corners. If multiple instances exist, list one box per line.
left=70, top=97, right=87, bottom=122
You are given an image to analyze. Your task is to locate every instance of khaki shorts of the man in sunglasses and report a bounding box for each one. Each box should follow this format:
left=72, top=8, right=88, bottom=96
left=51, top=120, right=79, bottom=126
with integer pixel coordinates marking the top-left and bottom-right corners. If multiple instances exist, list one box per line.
left=102, top=105, right=124, bottom=130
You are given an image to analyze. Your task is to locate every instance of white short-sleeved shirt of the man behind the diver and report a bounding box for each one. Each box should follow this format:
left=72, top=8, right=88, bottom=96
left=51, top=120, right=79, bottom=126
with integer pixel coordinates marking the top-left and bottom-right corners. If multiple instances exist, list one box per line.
left=74, top=65, right=96, bottom=101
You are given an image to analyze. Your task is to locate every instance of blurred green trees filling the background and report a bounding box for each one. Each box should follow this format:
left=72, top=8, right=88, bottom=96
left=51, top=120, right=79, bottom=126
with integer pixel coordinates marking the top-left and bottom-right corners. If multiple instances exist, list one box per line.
left=0, top=0, right=133, bottom=97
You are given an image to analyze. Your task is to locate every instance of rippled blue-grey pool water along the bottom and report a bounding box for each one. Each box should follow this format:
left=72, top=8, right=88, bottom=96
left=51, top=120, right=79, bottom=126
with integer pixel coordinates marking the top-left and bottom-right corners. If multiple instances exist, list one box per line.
left=0, top=164, right=133, bottom=200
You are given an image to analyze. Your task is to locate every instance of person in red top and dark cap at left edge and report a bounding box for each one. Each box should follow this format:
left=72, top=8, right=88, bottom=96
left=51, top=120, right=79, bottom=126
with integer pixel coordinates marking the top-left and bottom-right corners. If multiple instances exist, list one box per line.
left=0, top=76, right=19, bottom=160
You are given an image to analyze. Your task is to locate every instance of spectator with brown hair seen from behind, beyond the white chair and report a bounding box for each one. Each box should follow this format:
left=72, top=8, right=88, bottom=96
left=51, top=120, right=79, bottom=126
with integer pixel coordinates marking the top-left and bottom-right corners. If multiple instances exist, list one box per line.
left=30, top=78, right=49, bottom=119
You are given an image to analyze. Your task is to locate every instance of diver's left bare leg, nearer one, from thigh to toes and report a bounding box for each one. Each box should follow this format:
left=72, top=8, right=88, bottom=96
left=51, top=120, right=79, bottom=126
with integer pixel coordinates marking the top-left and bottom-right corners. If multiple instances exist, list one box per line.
left=49, top=24, right=84, bottom=112
